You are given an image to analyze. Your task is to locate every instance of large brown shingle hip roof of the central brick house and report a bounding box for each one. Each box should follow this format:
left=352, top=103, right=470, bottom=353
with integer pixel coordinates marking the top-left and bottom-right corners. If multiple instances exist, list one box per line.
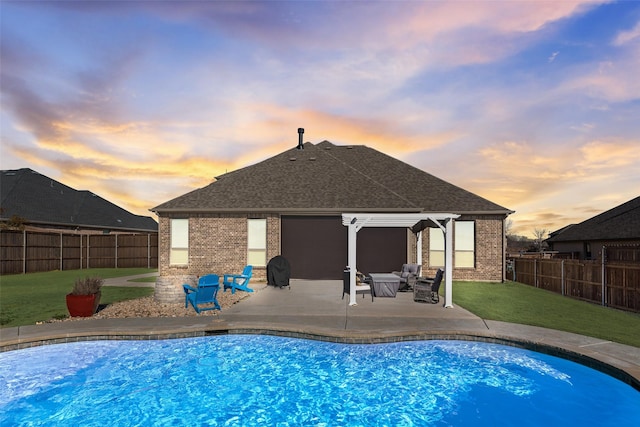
left=151, top=141, right=512, bottom=215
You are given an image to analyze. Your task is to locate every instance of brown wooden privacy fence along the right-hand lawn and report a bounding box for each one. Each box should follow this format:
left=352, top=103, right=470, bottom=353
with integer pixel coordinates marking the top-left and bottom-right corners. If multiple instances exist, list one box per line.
left=507, top=248, right=640, bottom=312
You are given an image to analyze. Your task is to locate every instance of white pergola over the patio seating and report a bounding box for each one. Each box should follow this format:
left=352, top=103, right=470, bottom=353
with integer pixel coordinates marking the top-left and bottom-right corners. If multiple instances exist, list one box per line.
left=342, top=213, right=460, bottom=308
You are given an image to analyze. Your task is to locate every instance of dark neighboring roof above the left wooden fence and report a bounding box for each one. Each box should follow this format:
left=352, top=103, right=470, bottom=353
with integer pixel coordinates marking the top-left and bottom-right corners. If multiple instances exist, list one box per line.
left=0, top=168, right=158, bottom=232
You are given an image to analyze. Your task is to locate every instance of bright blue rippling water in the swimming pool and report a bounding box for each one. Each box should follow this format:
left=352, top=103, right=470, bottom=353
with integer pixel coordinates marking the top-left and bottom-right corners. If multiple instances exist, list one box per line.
left=0, top=335, right=640, bottom=427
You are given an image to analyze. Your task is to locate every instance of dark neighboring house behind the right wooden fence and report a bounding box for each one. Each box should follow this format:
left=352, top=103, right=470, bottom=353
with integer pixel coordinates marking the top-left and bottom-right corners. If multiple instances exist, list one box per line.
left=546, top=197, right=640, bottom=259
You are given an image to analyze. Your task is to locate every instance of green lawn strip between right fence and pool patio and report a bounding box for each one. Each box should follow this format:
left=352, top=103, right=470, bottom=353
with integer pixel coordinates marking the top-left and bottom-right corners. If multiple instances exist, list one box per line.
left=453, top=282, right=640, bottom=347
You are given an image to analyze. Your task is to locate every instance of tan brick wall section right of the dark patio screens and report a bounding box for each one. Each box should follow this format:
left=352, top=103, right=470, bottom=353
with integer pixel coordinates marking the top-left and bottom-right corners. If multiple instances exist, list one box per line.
left=422, top=215, right=506, bottom=282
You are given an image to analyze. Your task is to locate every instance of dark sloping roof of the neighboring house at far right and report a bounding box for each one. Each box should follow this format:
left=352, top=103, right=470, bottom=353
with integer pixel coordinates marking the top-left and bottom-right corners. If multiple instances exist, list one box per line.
left=546, top=197, right=640, bottom=243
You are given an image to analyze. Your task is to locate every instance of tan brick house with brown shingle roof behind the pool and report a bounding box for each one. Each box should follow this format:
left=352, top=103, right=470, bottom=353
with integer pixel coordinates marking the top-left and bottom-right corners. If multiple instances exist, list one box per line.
left=151, top=134, right=512, bottom=298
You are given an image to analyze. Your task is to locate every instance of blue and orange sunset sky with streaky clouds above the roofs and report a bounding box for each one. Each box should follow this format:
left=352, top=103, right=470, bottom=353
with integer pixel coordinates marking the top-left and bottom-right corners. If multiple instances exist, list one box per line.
left=0, top=0, right=640, bottom=237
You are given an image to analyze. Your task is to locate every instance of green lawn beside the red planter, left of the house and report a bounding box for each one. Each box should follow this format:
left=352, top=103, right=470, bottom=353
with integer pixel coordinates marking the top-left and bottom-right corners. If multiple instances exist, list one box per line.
left=0, top=268, right=157, bottom=328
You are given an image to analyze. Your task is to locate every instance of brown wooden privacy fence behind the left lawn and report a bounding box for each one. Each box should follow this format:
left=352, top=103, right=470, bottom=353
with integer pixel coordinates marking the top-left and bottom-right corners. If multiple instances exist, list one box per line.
left=0, top=230, right=158, bottom=275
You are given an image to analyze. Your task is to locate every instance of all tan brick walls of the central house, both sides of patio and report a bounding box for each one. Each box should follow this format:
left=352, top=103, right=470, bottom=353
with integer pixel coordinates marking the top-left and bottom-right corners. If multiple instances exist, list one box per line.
left=156, top=214, right=506, bottom=302
